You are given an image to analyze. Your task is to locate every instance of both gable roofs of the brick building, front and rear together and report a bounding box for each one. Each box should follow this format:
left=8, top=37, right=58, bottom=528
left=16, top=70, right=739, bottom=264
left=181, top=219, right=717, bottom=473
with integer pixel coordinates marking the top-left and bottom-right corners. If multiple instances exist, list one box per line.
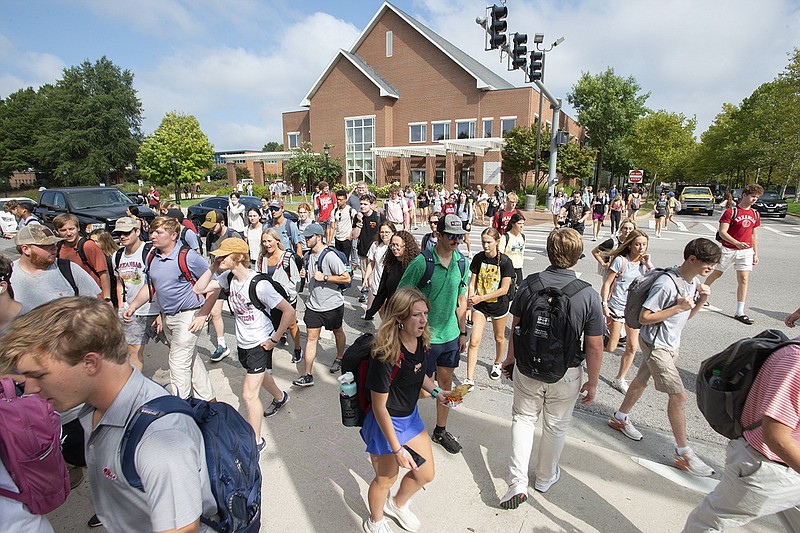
left=300, top=2, right=514, bottom=107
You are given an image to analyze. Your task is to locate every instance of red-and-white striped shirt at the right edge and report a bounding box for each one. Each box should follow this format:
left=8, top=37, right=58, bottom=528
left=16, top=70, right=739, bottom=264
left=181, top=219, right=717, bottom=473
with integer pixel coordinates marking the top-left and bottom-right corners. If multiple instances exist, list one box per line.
left=742, top=337, right=800, bottom=463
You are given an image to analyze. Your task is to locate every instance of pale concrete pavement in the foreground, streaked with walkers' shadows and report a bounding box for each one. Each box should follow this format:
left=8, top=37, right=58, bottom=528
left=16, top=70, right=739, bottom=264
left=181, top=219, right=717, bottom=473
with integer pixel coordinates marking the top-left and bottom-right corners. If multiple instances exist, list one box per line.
left=49, top=342, right=782, bottom=533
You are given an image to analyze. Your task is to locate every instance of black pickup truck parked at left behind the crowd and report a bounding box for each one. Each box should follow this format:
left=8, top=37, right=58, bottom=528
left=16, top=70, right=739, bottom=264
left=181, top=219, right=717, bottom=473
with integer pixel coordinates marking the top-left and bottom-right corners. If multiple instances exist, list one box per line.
left=34, top=187, right=155, bottom=235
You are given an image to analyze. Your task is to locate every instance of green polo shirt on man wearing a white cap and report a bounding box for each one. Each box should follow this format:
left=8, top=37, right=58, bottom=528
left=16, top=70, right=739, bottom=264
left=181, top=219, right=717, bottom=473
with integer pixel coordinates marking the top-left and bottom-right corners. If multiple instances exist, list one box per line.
left=397, top=249, right=469, bottom=344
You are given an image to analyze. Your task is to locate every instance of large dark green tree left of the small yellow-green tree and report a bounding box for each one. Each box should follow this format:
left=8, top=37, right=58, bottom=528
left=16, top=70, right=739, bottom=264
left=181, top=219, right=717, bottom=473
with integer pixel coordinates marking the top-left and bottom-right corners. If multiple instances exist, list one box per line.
left=34, top=56, right=142, bottom=185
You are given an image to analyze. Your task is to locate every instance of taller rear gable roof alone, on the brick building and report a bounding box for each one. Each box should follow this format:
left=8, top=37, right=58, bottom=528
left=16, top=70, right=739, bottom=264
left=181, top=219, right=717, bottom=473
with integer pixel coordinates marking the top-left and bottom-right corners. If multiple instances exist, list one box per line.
left=350, top=2, right=514, bottom=90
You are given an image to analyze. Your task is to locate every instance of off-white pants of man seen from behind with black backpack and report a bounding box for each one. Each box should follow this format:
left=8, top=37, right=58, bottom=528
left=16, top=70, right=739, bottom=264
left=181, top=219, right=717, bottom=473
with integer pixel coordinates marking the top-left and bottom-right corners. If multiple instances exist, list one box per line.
left=509, top=367, right=582, bottom=486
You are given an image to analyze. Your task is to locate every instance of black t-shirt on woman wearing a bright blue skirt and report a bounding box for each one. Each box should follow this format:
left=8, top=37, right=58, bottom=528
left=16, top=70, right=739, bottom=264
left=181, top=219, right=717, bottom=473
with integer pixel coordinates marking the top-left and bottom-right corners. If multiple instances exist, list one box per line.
left=366, top=339, right=427, bottom=417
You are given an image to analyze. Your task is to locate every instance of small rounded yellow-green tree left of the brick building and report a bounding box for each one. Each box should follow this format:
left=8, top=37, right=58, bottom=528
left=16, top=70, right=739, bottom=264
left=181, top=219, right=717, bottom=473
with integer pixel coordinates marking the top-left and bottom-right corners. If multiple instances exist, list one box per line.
left=137, top=111, right=214, bottom=185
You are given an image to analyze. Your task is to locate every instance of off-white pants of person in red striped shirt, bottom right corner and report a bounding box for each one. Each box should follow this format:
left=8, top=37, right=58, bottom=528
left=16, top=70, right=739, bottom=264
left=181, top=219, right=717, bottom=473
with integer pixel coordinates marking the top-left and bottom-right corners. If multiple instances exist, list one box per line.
left=683, top=438, right=800, bottom=533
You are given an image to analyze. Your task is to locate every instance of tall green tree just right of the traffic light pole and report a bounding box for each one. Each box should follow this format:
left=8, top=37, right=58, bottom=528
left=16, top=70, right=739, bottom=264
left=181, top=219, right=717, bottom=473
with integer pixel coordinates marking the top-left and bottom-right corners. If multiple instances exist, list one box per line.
left=567, top=67, right=650, bottom=189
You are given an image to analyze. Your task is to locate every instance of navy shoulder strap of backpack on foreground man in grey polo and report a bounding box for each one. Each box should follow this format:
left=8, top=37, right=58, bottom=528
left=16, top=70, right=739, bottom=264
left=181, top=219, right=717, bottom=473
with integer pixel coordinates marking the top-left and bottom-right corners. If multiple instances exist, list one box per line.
left=120, top=394, right=194, bottom=492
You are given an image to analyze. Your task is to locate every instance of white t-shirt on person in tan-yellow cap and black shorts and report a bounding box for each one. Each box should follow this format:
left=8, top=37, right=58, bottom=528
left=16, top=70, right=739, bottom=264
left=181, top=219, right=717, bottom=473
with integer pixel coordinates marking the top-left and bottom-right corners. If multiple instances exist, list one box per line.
left=218, top=272, right=283, bottom=349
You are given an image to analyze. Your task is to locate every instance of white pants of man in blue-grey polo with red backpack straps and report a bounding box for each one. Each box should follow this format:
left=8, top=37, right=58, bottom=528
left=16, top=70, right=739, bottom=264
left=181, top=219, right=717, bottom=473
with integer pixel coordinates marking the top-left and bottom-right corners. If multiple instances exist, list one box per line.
left=161, top=309, right=214, bottom=400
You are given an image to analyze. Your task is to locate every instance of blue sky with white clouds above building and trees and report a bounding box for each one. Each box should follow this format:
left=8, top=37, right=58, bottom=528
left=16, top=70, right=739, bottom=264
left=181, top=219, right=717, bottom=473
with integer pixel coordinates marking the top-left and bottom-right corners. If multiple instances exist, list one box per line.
left=0, top=0, right=800, bottom=151
